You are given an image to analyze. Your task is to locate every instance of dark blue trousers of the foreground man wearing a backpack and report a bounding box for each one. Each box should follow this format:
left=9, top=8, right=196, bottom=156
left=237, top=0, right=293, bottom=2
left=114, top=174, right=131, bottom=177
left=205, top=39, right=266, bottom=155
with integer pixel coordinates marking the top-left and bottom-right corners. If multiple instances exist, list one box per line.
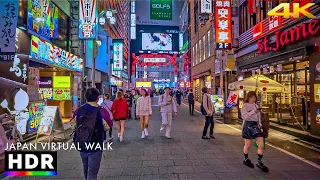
left=87, top=151, right=102, bottom=180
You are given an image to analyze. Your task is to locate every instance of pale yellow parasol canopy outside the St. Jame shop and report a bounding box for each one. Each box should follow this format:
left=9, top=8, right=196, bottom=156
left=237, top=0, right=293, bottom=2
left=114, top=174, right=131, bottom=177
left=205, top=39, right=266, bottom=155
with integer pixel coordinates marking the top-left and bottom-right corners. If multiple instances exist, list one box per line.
left=228, top=75, right=284, bottom=93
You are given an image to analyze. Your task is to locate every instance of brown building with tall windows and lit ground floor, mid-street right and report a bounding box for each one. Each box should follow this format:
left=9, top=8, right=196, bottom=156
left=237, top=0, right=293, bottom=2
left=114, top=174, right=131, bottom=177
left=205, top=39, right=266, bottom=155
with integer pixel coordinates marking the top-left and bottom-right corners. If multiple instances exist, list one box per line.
left=189, top=0, right=219, bottom=102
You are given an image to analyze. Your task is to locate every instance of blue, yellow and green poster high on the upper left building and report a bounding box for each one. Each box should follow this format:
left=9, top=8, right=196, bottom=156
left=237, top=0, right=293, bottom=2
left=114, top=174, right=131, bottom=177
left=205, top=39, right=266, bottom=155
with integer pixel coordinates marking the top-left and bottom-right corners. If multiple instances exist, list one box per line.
left=28, top=0, right=51, bottom=39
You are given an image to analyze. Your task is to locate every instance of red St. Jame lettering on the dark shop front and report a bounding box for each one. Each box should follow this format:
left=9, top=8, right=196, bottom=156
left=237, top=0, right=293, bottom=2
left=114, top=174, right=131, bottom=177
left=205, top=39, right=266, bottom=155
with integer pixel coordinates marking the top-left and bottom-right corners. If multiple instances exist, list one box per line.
left=257, top=19, right=320, bottom=54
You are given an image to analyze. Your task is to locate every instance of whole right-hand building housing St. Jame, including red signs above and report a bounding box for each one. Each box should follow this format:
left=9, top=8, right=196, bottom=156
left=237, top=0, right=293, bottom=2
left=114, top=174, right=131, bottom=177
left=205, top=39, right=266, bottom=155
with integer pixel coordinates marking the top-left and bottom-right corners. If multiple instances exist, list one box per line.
left=236, top=0, right=320, bottom=135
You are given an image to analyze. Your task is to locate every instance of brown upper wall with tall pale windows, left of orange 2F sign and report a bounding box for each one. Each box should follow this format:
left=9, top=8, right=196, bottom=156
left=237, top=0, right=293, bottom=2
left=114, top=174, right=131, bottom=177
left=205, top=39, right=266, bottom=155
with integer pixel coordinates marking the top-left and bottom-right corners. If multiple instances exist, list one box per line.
left=189, top=0, right=216, bottom=101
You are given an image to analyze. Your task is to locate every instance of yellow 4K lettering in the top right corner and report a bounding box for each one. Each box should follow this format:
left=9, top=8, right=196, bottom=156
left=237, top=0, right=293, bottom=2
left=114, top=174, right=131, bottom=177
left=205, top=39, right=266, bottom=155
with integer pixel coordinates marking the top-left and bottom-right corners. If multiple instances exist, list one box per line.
left=268, top=3, right=316, bottom=19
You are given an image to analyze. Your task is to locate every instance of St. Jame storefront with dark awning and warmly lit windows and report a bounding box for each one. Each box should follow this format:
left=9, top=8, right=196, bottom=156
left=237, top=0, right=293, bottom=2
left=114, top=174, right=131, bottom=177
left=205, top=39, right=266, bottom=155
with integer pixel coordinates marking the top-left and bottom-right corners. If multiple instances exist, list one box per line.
left=236, top=7, right=320, bottom=134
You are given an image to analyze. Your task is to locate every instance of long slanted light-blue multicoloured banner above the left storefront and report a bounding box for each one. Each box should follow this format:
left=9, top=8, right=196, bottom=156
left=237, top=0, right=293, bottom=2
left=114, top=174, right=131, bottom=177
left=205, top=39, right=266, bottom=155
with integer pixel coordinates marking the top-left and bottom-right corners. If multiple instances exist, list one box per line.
left=31, top=36, right=83, bottom=72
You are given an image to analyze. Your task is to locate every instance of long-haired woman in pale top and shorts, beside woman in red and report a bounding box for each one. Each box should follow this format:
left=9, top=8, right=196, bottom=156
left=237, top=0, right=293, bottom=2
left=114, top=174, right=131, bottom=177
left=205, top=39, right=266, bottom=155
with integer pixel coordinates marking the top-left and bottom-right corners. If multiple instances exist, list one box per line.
left=136, top=89, right=152, bottom=139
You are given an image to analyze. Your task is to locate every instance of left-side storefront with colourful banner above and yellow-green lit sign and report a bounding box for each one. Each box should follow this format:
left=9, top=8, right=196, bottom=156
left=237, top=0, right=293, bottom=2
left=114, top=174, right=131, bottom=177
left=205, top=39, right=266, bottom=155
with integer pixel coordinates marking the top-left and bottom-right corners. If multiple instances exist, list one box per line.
left=28, top=35, right=83, bottom=125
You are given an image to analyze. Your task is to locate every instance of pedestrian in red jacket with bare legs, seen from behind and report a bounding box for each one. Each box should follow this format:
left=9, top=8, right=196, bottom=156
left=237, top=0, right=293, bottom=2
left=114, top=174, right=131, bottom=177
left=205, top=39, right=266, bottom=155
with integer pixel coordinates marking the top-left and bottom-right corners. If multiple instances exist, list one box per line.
left=111, top=91, right=128, bottom=142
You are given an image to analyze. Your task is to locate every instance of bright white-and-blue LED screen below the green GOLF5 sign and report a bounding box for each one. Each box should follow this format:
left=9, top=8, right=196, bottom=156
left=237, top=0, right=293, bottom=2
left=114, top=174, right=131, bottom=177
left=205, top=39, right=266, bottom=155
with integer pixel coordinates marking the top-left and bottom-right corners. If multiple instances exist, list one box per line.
left=142, top=33, right=172, bottom=51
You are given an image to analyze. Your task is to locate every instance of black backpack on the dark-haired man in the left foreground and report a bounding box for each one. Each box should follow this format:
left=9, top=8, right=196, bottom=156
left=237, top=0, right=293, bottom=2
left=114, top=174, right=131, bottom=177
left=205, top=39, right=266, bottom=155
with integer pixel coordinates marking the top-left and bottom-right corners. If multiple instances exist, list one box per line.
left=73, top=105, right=101, bottom=150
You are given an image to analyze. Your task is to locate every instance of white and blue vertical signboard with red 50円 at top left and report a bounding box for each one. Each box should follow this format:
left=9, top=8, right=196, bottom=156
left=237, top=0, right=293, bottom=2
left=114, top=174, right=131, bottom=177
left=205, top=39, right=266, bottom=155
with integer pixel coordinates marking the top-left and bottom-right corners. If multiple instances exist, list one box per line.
left=79, top=0, right=98, bottom=39
